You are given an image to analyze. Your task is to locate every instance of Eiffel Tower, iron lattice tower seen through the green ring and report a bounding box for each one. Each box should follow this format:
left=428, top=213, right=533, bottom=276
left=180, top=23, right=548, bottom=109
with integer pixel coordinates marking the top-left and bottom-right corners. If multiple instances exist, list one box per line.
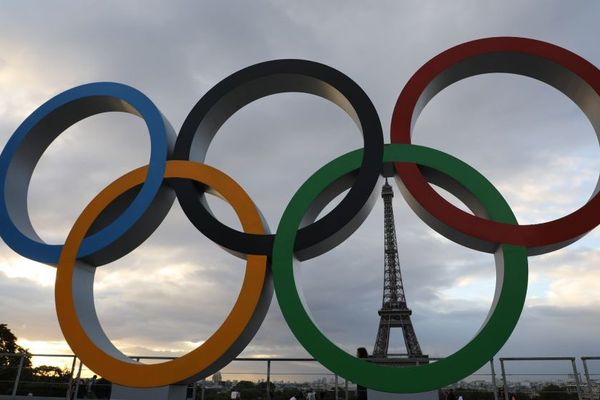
left=373, top=179, right=425, bottom=358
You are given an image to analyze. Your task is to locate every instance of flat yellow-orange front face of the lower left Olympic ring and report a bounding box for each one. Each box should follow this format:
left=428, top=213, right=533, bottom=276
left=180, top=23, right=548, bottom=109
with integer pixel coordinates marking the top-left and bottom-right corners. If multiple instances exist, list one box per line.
left=55, top=161, right=270, bottom=388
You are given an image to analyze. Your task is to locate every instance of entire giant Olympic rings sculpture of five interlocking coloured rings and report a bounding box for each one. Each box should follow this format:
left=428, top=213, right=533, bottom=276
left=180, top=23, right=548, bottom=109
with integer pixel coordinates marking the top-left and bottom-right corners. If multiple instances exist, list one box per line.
left=0, top=37, right=600, bottom=392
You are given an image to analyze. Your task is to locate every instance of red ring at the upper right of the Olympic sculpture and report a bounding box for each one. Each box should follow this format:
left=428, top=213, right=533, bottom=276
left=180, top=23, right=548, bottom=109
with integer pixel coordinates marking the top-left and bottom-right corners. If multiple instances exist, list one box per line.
left=391, top=37, right=600, bottom=255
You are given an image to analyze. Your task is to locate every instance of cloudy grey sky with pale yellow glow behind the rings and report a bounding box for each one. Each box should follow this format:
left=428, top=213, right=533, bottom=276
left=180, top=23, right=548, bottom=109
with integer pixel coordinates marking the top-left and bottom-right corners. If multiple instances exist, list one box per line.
left=0, top=1, right=600, bottom=382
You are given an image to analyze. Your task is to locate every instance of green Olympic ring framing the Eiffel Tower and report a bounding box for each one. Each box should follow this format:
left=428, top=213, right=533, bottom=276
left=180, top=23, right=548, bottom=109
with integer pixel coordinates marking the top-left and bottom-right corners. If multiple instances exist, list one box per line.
left=272, top=144, right=528, bottom=393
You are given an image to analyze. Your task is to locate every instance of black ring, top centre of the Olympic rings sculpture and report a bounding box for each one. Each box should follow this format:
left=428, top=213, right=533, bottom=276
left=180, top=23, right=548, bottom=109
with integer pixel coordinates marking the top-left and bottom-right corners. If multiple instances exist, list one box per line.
left=172, top=60, right=383, bottom=260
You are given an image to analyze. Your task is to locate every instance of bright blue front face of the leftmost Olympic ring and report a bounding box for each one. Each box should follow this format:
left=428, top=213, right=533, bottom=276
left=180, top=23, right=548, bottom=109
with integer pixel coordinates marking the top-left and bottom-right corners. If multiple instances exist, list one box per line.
left=0, top=82, right=172, bottom=263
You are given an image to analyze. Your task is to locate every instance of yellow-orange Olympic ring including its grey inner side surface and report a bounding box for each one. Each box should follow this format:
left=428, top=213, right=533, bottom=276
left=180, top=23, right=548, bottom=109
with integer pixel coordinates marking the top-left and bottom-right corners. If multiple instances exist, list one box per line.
left=55, top=161, right=273, bottom=387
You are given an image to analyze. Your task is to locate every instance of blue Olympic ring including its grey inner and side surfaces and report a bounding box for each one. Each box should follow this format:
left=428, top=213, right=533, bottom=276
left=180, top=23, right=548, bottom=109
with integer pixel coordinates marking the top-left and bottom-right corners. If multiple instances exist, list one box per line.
left=0, top=82, right=175, bottom=265
